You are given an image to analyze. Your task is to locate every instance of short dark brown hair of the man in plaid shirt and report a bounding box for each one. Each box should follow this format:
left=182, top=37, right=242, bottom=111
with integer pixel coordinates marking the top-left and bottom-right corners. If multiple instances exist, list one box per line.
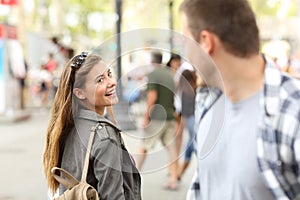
left=180, top=0, right=260, bottom=57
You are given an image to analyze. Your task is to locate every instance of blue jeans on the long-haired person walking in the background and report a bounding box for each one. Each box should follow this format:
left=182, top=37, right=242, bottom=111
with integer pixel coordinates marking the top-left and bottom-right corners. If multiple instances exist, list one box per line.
left=184, top=115, right=196, bottom=161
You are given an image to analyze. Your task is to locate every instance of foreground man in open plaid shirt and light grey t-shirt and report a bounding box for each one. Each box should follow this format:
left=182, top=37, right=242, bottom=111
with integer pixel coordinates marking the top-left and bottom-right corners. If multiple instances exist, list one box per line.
left=180, top=0, right=300, bottom=200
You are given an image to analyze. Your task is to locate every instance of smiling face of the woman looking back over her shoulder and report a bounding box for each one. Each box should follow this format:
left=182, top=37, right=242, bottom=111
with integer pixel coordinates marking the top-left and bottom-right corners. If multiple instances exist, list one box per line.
left=77, top=61, right=118, bottom=115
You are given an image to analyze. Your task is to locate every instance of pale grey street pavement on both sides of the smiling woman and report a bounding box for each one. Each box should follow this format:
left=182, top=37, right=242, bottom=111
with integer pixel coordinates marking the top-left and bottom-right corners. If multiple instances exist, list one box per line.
left=0, top=109, right=196, bottom=200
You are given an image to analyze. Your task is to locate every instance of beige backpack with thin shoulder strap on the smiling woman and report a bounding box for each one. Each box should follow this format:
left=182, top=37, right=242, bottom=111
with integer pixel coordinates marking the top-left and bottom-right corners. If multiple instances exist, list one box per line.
left=51, top=124, right=99, bottom=200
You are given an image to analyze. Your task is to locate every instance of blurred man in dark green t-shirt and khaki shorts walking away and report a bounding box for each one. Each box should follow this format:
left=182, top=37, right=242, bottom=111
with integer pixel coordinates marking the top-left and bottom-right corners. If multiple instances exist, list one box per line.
left=137, top=52, right=178, bottom=190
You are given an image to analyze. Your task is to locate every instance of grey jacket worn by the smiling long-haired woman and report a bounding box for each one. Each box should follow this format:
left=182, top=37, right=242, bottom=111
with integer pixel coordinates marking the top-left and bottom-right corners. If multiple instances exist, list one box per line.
left=59, top=110, right=141, bottom=200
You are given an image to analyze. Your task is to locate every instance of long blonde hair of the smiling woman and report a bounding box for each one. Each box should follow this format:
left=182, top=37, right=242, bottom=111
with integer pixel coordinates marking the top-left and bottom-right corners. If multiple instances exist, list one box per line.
left=43, top=55, right=102, bottom=193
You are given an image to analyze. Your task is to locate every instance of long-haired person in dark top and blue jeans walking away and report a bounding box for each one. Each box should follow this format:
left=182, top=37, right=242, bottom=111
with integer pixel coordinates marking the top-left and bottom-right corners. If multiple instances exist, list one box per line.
left=178, top=70, right=197, bottom=180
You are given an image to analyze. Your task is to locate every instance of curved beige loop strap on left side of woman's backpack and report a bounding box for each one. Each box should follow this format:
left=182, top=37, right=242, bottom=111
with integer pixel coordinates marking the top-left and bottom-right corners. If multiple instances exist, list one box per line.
left=51, top=167, right=79, bottom=190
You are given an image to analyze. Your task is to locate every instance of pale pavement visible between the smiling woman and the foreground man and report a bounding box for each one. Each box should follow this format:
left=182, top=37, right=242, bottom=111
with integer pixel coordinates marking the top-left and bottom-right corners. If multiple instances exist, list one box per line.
left=124, top=130, right=196, bottom=200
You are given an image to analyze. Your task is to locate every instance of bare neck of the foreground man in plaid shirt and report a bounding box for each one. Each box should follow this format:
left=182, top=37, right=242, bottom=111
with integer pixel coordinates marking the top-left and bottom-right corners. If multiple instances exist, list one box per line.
left=216, top=54, right=265, bottom=102
